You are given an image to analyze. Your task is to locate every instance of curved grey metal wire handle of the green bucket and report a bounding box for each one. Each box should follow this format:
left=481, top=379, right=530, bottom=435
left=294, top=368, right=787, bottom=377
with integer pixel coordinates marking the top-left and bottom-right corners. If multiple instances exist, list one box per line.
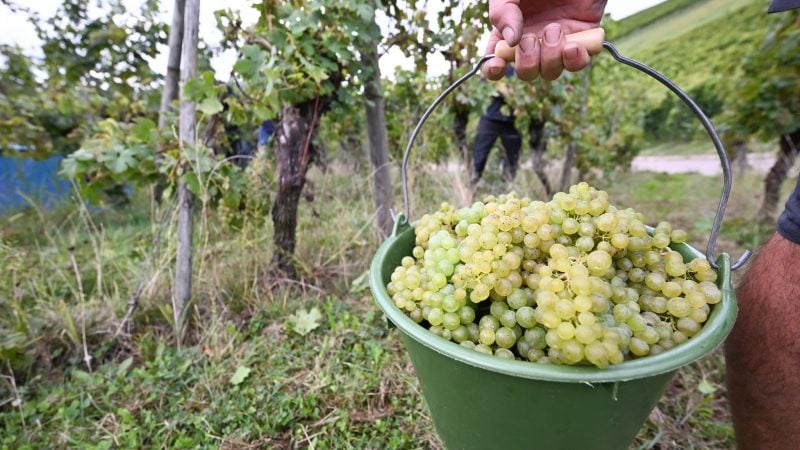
left=395, top=41, right=752, bottom=270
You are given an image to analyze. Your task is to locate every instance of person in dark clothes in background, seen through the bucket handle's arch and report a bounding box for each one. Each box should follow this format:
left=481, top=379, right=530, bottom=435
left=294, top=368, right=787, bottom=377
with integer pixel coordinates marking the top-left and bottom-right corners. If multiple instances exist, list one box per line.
left=472, top=64, right=522, bottom=190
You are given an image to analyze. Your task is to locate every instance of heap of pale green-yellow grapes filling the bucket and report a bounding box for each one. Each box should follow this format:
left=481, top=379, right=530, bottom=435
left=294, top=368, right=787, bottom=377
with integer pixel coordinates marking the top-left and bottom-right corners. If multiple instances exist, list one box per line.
left=387, top=183, right=722, bottom=368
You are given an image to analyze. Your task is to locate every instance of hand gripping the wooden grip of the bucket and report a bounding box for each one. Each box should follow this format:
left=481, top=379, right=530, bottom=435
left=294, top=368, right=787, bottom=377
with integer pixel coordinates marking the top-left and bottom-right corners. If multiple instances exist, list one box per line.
left=483, top=0, right=606, bottom=80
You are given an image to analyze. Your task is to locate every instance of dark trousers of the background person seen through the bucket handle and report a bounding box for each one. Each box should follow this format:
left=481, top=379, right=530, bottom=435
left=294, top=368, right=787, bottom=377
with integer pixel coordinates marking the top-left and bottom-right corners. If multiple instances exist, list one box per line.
left=473, top=117, right=522, bottom=183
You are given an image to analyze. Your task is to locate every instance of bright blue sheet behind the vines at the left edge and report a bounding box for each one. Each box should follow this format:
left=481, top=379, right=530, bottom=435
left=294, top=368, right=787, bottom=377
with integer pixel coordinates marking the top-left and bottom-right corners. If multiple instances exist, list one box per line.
left=0, top=154, right=71, bottom=213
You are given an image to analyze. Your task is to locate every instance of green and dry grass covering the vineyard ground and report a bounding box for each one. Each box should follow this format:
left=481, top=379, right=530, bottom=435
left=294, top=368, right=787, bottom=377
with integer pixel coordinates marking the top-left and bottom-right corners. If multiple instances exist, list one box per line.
left=0, top=153, right=788, bottom=449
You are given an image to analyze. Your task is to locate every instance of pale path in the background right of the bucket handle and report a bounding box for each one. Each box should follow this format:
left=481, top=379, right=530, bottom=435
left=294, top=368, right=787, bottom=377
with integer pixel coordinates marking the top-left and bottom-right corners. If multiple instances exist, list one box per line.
left=631, top=153, right=775, bottom=175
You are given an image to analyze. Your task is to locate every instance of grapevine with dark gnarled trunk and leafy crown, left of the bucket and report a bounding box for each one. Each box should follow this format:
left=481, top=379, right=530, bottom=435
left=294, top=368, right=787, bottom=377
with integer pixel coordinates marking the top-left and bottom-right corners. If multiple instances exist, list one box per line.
left=217, top=0, right=377, bottom=277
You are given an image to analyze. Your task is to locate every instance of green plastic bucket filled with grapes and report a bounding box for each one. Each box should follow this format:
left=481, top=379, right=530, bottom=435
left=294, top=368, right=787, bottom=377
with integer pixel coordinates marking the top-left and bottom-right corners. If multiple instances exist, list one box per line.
left=370, top=220, right=737, bottom=450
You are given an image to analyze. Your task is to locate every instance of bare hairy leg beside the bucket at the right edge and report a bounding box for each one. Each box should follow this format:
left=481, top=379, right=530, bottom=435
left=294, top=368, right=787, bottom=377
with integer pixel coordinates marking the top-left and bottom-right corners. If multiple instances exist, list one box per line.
left=725, top=233, right=800, bottom=450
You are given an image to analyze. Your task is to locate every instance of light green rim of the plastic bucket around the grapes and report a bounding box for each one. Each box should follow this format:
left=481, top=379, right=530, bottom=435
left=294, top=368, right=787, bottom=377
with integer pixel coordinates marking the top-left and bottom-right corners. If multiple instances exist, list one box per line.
left=369, top=226, right=738, bottom=384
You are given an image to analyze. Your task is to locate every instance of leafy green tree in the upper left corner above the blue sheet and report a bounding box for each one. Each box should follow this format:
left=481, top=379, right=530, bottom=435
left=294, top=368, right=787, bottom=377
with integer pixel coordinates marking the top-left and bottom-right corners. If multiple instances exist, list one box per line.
left=0, top=0, right=165, bottom=167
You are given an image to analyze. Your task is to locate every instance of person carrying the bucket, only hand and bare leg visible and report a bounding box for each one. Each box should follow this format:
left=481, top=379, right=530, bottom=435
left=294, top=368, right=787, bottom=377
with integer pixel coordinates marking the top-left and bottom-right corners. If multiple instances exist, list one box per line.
left=483, top=0, right=800, bottom=450
